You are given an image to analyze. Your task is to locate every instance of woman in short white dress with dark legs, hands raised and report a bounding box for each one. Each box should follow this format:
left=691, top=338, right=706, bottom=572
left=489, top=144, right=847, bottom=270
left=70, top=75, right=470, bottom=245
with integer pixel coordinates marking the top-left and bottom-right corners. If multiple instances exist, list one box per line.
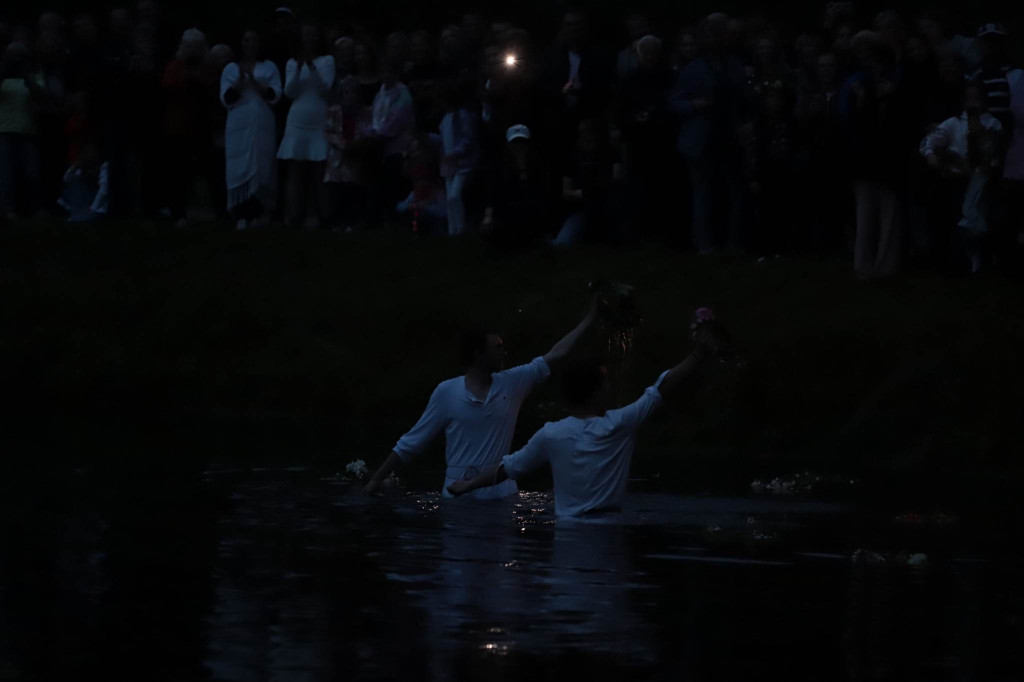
left=278, top=26, right=334, bottom=225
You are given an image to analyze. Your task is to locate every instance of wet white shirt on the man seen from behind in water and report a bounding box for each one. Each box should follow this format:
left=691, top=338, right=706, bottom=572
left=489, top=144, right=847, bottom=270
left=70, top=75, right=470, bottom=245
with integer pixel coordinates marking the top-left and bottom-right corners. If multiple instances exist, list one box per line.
left=502, top=372, right=668, bottom=516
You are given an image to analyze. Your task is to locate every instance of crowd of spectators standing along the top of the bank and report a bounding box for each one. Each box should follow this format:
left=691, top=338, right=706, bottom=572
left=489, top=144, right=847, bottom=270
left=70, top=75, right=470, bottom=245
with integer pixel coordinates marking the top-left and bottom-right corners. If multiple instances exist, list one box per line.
left=0, top=0, right=1024, bottom=280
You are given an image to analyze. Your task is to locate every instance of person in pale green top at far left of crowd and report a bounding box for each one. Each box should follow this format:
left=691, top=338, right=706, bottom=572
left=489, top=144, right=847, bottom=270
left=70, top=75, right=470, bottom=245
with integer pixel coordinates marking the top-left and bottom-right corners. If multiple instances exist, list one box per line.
left=0, top=42, right=46, bottom=219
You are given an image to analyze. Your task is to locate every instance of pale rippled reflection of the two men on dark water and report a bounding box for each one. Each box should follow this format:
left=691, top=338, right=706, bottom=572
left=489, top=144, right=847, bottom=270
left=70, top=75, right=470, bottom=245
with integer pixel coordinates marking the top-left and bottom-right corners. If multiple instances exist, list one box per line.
left=382, top=494, right=651, bottom=667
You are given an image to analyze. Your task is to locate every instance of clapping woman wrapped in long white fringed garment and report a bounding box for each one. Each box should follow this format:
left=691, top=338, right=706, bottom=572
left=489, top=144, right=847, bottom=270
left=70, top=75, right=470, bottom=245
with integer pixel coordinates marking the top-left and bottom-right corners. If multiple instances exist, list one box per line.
left=220, top=31, right=281, bottom=229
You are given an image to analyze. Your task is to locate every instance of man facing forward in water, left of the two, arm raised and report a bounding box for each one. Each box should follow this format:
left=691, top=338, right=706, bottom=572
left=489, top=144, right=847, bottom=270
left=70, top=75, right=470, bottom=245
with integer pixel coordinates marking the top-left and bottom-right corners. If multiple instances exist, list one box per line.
left=364, top=298, right=597, bottom=500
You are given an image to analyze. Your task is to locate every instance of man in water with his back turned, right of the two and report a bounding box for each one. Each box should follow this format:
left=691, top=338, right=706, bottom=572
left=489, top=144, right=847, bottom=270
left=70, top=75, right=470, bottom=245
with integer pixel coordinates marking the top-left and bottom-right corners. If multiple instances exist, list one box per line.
left=447, top=326, right=719, bottom=516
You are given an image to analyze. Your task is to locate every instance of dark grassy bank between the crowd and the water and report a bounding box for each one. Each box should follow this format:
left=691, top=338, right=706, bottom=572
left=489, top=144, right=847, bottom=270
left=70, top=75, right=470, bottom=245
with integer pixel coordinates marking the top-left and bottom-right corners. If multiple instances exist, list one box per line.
left=0, top=225, right=1024, bottom=509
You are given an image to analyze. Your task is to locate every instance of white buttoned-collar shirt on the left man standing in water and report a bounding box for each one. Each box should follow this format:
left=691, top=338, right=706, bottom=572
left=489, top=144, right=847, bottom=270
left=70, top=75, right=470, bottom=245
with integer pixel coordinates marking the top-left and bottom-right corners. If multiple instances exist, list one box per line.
left=394, top=357, right=551, bottom=499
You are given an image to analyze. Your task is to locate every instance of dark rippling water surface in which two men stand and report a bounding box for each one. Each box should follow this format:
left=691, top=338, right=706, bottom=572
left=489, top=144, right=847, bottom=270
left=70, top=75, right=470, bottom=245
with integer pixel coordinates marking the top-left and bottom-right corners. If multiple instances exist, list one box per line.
left=0, top=466, right=1024, bottom=682
